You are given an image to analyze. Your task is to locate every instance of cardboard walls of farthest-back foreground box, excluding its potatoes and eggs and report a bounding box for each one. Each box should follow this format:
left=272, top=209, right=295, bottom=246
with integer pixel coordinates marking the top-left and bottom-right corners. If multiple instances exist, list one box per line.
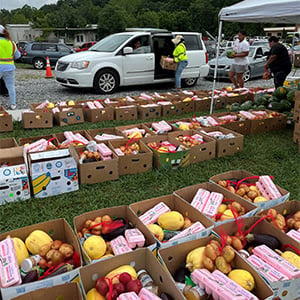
left=209, top=170, right=290, bottom=210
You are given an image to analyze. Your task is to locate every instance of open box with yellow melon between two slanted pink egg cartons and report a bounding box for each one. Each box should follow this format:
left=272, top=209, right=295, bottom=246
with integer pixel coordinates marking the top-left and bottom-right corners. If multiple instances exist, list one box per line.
left=129, top=194, right=213, bottom=248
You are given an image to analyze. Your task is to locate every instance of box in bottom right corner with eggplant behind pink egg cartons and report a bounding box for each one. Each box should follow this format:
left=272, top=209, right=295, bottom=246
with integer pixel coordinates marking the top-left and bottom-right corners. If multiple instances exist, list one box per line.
left=214, top=215, right=300, bottom=300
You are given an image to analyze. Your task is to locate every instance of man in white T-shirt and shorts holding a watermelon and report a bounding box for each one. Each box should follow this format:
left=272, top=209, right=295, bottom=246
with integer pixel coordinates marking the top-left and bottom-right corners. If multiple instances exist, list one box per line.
left=228, top=30, right=250, bottom=88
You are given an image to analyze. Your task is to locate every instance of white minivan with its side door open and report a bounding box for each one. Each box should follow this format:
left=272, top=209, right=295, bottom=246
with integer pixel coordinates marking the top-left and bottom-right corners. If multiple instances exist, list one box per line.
left=55, top=29, right=209, bottom=94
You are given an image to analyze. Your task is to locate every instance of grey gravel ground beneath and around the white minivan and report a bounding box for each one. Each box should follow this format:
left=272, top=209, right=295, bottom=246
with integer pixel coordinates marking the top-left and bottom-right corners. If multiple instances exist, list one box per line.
left=0, top=68, right=273, bottom=109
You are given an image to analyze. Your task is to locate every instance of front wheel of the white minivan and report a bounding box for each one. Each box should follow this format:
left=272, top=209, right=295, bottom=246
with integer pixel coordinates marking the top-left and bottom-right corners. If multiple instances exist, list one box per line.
left=93, top=69, right=119, bottom=94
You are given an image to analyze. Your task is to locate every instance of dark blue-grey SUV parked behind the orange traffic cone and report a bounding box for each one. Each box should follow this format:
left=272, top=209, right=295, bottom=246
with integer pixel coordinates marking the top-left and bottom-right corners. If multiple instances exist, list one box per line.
left=22, top=42, right=75, bottom=70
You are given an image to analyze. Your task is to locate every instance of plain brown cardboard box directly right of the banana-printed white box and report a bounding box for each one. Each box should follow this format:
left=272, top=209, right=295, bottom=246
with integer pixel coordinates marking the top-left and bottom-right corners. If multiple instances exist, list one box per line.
left=70, top=146, right=119, bottom=184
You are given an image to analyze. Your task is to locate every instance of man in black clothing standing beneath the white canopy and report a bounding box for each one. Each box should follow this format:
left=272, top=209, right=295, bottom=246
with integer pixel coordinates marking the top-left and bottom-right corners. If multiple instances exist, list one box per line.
left=265, top=36, right=292, bottom=88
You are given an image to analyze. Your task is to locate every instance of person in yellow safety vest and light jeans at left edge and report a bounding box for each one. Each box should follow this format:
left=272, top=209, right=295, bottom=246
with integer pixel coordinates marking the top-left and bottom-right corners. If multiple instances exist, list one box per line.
left=0, top=25, right=21, bottom=109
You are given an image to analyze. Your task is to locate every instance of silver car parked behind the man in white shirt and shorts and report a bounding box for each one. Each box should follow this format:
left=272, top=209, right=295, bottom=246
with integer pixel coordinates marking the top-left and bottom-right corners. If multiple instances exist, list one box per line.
left=207, top=46, right=269, bottom=82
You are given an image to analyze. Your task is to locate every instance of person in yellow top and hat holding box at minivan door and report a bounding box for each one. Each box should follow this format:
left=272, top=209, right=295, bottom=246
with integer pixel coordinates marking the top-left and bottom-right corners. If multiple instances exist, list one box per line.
left=172, top=35, right=189, bottom=90
